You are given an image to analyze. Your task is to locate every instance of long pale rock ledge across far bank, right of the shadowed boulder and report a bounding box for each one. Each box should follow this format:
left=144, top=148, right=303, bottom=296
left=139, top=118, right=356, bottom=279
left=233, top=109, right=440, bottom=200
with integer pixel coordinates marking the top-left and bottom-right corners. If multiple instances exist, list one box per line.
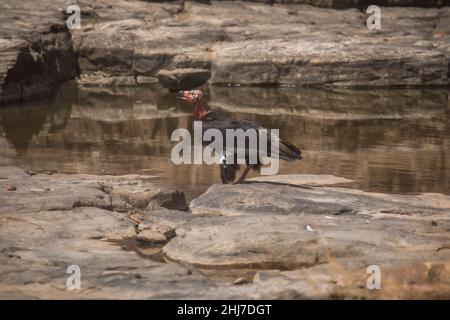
left=73, top=0, right=450, bottom=87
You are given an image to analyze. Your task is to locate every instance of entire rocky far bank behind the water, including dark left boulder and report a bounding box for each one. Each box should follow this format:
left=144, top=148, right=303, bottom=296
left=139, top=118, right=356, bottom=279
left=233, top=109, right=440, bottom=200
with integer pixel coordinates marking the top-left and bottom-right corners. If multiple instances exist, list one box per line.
left=0, top=0, right=450, bottom=103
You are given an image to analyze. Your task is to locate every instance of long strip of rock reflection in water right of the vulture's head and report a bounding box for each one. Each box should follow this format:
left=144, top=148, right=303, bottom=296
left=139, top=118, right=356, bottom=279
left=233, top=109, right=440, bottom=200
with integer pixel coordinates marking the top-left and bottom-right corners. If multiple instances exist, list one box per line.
left=210, top=87, right=447, bottom=119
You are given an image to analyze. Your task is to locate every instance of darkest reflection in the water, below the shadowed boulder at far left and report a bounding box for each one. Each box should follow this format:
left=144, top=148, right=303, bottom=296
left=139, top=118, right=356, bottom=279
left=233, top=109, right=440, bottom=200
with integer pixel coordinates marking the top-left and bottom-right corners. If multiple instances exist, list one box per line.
left=0, top=88, right=71, bottom=154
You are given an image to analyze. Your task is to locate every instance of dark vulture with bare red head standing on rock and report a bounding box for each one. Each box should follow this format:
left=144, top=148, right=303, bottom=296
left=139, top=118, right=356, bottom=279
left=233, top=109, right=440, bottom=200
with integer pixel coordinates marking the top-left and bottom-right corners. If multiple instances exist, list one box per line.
left=176, top=90, right=302, bottom=184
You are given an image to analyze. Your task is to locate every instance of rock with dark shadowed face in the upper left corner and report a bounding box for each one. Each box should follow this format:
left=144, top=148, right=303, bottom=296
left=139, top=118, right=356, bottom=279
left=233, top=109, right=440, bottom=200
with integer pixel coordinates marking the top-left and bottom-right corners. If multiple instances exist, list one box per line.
left=0, top=0, right=77, bottom=104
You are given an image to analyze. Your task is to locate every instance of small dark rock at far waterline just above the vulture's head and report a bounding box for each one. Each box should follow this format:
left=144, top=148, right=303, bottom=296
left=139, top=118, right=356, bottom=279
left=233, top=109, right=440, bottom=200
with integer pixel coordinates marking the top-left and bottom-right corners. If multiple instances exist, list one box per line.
left=158, top=68, right=211, bottom=91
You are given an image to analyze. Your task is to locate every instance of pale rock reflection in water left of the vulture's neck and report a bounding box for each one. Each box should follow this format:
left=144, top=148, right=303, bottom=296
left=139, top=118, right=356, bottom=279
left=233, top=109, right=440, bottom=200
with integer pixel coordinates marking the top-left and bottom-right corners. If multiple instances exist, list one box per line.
left=64, top=87, right=191, bottom=156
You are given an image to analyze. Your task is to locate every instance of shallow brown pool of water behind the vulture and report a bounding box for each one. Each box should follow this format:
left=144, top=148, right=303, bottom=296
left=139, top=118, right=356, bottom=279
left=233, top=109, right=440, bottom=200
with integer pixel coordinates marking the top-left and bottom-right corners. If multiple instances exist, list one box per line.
left=0, top=84, right=450, bottom=197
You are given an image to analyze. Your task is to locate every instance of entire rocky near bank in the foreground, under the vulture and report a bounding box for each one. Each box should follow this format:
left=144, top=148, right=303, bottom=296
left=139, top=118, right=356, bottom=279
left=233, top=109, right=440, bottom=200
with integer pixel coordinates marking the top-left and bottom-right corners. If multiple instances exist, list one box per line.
left=0, top=167, right=450, bottom=299
